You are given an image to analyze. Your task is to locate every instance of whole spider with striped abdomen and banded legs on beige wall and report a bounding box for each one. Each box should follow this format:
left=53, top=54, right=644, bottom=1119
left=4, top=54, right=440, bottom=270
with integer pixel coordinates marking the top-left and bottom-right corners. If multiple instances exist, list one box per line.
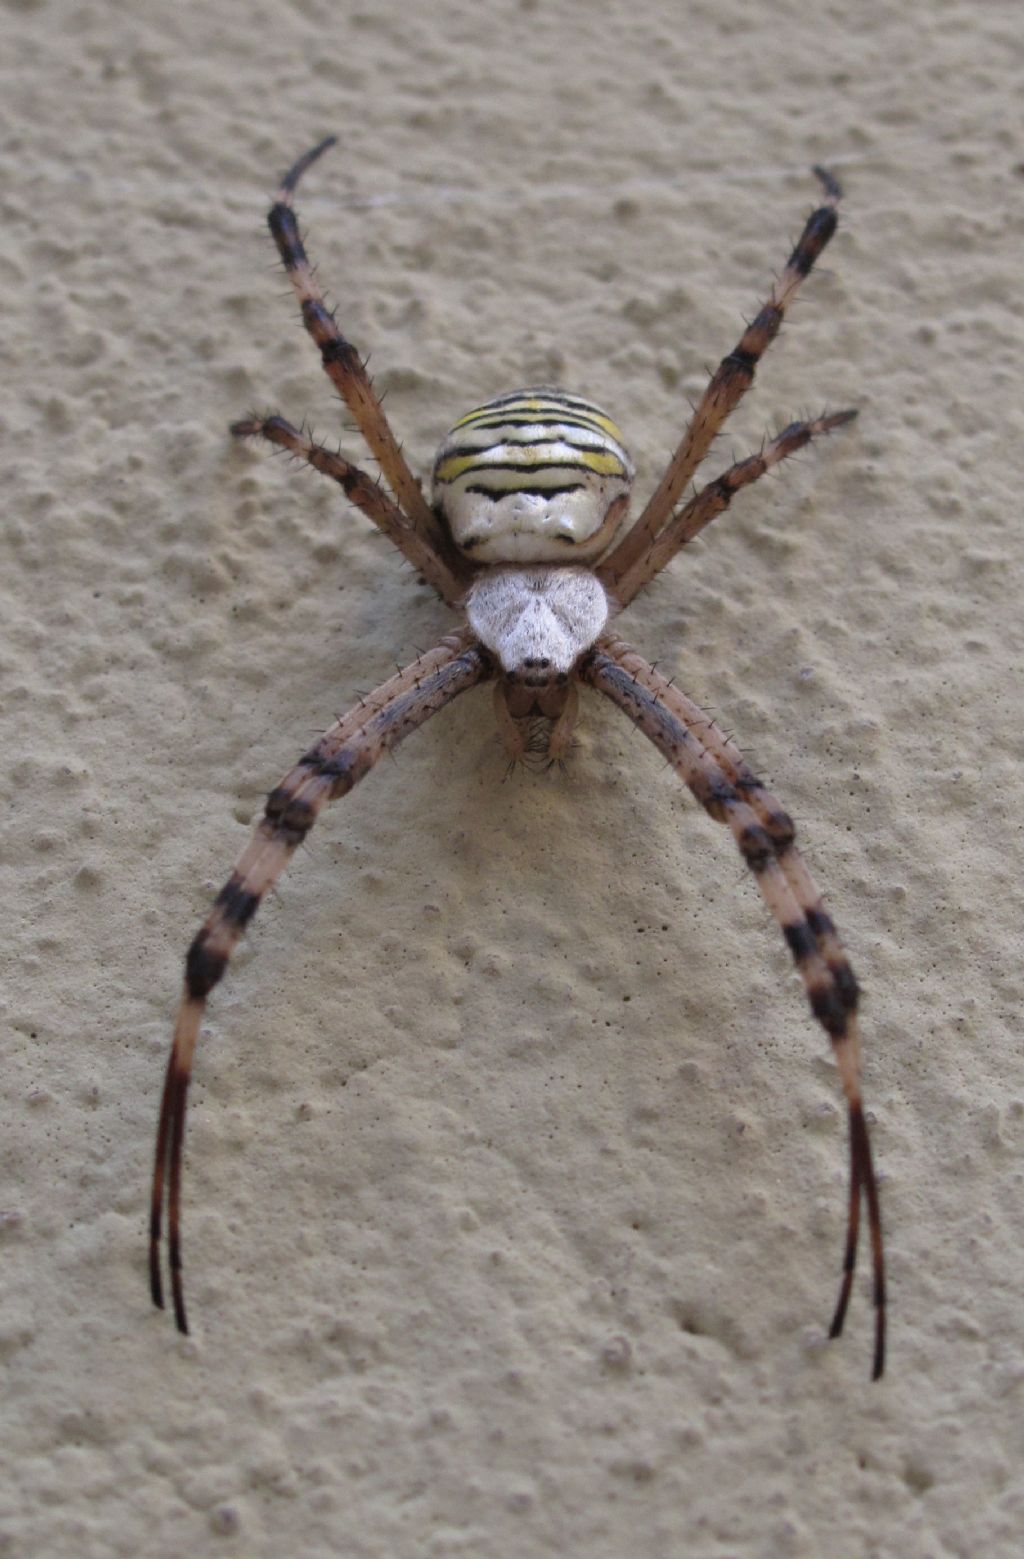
left=150, top=136, right=885, bottom=1380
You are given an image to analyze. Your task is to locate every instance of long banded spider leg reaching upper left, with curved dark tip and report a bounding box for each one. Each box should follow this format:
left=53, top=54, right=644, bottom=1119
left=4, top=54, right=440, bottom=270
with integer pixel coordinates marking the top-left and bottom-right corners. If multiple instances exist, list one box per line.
left=267, top=136, right=440, bottom=544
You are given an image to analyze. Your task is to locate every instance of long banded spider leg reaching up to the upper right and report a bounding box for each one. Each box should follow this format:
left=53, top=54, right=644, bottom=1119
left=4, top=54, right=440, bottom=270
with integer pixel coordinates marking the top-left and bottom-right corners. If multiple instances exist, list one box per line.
left=600, top=168, right=843, bottom=594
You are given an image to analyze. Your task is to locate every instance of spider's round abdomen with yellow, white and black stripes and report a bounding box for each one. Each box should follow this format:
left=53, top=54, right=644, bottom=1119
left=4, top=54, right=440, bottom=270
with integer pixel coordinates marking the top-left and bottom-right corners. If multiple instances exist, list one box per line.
left=433, top=388, right=634, bottom=563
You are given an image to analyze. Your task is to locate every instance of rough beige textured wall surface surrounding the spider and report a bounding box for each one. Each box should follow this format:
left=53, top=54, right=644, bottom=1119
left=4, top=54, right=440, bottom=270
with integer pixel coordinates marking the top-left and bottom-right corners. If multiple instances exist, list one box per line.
left=0, top=0, right=1024, bottom=1559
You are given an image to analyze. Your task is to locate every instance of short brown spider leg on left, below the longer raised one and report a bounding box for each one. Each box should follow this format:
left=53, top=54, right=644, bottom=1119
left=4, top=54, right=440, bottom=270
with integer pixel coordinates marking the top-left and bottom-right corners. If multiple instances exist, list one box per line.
left=231, top=416, right=468, bottom=606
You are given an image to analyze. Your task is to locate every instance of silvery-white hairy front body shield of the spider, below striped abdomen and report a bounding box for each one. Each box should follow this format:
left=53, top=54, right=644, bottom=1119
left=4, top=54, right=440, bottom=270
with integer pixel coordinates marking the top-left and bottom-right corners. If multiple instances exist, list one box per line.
left=466, top=566, right=608, bottom=684
